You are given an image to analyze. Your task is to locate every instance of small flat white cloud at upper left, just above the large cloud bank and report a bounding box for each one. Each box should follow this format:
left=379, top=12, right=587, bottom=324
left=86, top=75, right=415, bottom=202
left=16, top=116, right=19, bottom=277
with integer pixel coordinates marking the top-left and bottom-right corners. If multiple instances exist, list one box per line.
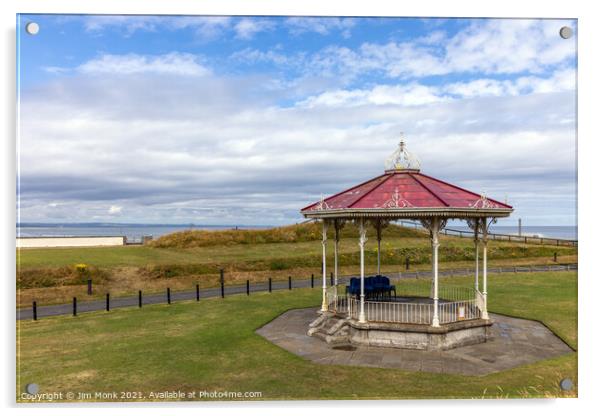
left=76, top=52, right=210, bottom=76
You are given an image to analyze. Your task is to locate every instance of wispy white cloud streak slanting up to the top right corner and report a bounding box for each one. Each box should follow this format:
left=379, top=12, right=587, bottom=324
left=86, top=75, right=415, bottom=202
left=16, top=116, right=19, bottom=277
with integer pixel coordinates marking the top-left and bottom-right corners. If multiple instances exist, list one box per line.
left=298, top=19, right=576, bottom=82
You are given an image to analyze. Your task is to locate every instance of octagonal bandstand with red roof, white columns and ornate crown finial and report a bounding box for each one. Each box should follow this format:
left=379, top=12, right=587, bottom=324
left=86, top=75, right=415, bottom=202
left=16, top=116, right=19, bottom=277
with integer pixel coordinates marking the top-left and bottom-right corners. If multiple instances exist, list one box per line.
left=301, top=139, right=513, bottom=350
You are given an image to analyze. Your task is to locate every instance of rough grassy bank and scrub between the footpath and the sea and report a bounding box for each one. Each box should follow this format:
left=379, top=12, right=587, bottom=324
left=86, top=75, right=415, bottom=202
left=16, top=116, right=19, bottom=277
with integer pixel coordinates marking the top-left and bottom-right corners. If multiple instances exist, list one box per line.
left=17, top=223, right=577, bottom=307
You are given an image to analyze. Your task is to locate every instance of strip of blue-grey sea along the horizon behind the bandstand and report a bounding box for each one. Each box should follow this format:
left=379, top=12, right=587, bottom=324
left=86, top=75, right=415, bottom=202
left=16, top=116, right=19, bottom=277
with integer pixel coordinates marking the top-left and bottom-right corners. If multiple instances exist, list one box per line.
left=17, top=223, right=578, bottom=240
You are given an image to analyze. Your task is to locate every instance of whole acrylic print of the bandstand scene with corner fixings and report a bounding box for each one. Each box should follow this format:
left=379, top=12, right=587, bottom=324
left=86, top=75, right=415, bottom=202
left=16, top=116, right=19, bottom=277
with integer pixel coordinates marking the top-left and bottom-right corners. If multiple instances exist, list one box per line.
left=16, top=14, right=577, bottom=403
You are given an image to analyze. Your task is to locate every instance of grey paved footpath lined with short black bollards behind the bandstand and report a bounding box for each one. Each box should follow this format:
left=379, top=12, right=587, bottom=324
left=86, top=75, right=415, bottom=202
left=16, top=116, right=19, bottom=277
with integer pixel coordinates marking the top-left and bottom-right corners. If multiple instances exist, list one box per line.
left=17, top=264, right=577, bottom=320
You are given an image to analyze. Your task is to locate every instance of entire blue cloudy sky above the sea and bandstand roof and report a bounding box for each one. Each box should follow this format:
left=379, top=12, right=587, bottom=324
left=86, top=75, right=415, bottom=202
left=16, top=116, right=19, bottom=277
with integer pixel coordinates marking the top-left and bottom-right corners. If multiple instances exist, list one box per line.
left=17, top=15, right=577, bottom=225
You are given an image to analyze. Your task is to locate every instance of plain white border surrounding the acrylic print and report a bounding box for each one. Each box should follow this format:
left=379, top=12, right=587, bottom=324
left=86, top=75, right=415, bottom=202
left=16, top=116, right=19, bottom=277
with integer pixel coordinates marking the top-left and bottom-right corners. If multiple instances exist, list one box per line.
left=0, top=0, right=602, bottom=415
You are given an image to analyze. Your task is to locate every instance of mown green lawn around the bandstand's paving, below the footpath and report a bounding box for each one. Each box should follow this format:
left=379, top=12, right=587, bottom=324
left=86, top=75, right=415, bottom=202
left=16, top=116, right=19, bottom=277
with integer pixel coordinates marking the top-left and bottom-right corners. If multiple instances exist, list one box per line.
left=17, top=272, right=577, bottom=400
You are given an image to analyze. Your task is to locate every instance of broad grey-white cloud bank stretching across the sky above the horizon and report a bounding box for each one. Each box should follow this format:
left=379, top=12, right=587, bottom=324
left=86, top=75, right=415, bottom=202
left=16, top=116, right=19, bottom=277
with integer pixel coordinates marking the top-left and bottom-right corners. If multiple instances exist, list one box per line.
left=20, top=55, right=575, bottom=224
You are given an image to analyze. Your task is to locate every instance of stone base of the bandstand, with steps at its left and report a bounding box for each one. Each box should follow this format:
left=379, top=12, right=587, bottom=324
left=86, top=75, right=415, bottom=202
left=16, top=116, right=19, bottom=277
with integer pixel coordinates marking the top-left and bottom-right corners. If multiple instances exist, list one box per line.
left=307, top=312, right=493, bottom=351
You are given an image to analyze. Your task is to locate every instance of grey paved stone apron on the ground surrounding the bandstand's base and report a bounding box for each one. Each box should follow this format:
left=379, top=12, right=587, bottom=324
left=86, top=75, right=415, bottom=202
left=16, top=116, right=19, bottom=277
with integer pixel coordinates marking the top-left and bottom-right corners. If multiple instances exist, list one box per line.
left=257, top=308, right=572, bottom=375
